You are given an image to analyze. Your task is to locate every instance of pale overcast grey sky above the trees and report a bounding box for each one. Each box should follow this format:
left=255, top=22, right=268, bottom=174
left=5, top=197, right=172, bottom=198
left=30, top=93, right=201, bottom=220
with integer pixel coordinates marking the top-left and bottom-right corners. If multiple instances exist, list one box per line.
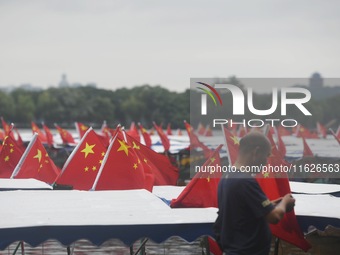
left=0, top=0, right=340, bottom=91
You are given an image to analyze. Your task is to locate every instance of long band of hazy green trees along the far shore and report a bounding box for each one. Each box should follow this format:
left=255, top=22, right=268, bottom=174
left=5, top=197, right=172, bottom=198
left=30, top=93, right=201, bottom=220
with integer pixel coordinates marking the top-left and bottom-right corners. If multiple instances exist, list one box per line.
left=0, top=81, right=340, bottom=128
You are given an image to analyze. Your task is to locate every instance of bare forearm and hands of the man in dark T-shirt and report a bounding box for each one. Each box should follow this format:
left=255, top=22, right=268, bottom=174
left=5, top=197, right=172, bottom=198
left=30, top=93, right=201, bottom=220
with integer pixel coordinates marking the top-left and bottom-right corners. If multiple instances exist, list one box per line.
left=266, top=194, right=295, bottom=224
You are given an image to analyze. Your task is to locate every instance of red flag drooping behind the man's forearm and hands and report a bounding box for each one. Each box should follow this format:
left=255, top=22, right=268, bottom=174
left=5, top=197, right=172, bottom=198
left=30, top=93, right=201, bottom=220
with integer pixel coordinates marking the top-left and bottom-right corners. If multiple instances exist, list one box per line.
left=256, top=133, right=311, bottom=251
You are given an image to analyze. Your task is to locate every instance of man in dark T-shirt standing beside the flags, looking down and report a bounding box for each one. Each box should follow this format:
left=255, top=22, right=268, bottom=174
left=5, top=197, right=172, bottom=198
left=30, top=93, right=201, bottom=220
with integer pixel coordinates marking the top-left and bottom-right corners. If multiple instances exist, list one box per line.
left=214, top=132, right=295, bottom=255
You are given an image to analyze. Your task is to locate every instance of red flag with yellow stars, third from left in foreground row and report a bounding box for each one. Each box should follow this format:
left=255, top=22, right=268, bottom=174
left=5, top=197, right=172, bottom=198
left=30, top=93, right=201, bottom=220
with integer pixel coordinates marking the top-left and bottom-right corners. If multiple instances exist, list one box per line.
left=56, top=128, right=106, bottom=190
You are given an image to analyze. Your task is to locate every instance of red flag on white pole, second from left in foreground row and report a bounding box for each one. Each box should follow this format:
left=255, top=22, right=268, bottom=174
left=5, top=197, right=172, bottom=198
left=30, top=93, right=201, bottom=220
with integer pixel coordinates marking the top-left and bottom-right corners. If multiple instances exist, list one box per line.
left=11, top=133, right=60, bottom=184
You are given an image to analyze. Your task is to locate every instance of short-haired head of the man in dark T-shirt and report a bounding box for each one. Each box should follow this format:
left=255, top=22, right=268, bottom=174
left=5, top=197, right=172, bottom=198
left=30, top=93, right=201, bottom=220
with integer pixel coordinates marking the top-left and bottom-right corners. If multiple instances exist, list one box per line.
left=237, top=132, right=271, bottom=166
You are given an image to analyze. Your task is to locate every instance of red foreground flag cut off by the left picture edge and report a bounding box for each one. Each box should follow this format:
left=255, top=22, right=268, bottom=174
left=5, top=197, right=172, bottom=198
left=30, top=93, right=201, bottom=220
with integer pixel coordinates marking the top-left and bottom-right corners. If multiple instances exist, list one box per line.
left=0, top=135, right=24, bottom=178
